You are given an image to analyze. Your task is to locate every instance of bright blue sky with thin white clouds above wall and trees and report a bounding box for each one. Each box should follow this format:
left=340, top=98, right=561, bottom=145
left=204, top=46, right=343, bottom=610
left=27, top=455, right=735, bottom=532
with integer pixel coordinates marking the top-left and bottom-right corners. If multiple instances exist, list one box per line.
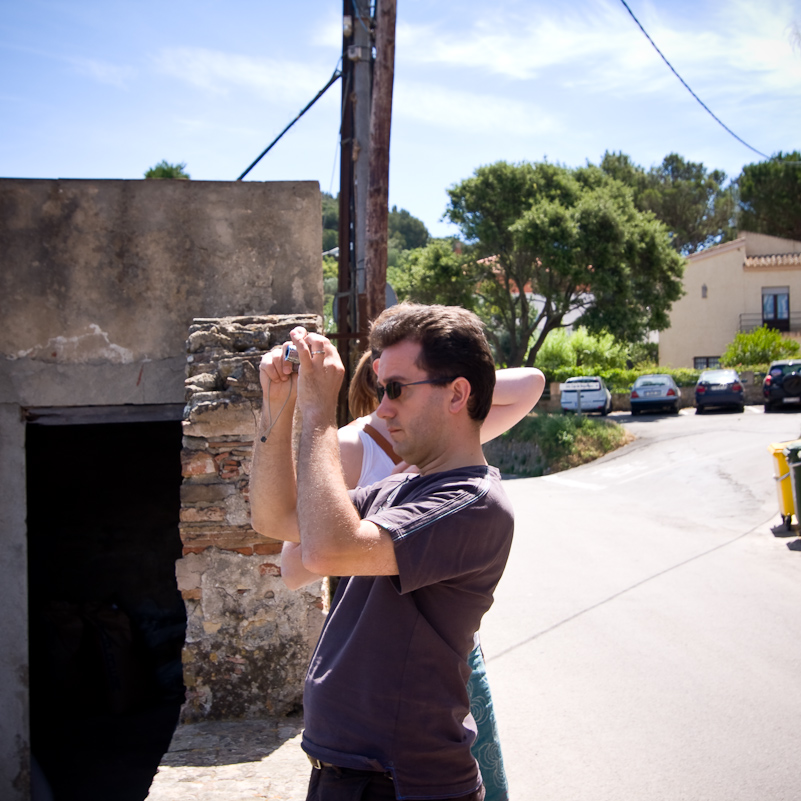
left=0, top=0, right=801, bottom=236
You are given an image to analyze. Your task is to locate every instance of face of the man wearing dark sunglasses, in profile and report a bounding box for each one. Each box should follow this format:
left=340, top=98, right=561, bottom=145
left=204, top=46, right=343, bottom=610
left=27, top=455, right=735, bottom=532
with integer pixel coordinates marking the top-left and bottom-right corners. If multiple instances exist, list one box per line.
left=376, top=340, right=450, bottom=471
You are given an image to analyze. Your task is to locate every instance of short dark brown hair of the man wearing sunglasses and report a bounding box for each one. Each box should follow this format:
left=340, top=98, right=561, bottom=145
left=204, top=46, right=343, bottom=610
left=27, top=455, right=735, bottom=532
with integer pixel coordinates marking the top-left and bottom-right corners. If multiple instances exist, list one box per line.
left=370, top=303, right=495, bottom=422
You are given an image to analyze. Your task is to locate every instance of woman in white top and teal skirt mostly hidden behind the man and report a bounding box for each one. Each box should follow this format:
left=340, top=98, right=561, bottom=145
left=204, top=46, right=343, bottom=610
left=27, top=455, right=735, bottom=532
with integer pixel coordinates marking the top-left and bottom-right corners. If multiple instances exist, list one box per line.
left=281, top=352, right=545, bottom=801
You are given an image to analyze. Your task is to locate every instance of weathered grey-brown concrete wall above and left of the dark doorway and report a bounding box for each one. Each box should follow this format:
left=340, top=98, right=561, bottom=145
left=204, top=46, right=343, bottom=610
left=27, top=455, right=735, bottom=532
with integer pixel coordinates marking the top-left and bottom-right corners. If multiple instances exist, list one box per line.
left=0, top=179, right=323, bottom=801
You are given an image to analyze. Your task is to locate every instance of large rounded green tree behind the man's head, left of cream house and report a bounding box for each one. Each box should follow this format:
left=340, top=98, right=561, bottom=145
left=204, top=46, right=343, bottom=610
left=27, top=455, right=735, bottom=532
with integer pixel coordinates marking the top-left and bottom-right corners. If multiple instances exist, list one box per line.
left=445, top=161, right=684, bottom=366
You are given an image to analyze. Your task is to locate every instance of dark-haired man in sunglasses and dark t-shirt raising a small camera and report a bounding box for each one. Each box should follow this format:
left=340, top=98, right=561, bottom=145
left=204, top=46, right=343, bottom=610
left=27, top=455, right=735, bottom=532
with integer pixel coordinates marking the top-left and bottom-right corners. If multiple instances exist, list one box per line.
left=251, top=304, right=513, bottom=801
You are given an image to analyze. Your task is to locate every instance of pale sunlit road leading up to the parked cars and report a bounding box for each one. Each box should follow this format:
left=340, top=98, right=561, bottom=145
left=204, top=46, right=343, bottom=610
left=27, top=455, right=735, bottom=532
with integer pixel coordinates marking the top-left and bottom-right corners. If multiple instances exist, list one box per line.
left=482, top=407, right=801, bottom=801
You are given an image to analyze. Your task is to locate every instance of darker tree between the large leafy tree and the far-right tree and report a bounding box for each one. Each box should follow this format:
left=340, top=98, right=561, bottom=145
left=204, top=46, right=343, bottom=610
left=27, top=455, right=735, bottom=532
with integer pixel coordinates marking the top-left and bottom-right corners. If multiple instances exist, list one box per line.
left=601, top=151, right=735, bottom=256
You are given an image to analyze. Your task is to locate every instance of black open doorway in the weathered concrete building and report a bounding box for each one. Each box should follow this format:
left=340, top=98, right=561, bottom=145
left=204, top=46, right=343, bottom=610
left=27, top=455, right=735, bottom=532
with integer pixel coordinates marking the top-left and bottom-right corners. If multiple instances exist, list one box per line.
left=26, top=420, right=186, bottom=801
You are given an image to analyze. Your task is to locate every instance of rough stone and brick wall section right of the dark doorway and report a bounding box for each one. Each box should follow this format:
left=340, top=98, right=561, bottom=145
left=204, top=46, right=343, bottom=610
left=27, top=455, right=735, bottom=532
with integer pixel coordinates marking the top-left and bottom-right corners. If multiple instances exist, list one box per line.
left=176, top=315, right=323, bottom=722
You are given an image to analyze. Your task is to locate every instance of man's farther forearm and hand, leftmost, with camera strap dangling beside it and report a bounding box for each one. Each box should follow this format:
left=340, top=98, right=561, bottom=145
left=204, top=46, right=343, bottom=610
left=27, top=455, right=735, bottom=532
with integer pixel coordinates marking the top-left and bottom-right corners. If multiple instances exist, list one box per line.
left=250, top=349, right=300, bottom=542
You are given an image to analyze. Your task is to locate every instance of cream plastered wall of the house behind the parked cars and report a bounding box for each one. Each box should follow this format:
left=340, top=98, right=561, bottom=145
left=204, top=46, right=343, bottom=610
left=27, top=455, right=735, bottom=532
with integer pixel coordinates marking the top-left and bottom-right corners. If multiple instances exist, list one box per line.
left=659, top=232, right=801, bottom=367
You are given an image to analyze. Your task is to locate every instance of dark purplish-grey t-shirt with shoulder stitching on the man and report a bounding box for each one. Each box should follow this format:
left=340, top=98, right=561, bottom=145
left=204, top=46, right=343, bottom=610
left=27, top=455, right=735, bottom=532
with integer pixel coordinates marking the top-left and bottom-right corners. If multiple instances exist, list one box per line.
left=303, top=465, right=514, bottom=798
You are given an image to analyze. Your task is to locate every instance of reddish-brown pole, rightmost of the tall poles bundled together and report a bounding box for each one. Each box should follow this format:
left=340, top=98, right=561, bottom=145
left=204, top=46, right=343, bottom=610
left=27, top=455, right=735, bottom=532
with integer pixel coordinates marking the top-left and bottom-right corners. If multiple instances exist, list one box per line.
left=365, top=0, right=397, bottom=320
